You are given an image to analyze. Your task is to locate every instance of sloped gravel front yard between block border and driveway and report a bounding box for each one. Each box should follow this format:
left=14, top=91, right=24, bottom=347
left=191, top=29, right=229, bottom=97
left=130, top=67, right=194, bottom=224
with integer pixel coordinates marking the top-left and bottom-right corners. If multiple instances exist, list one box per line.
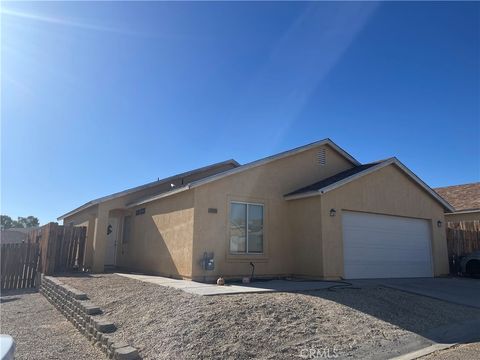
left=56, top=274, right=480, bottom=359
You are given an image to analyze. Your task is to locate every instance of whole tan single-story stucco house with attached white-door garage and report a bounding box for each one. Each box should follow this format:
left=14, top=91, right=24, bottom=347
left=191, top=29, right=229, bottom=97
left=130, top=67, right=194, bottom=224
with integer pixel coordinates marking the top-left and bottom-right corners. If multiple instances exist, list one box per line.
left=59, top=139, right=453, bottom=281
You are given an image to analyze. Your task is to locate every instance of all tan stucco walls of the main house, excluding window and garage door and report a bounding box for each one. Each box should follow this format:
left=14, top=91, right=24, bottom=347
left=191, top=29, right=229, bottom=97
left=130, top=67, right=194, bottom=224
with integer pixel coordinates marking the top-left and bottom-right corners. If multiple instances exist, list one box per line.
left=64, top=145, right=448, bottom=280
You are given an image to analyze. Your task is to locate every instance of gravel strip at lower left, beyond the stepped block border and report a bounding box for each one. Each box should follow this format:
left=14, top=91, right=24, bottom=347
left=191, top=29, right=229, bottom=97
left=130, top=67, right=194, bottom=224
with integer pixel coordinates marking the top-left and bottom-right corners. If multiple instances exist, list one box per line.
left=0, top=293, right=105, bottom=360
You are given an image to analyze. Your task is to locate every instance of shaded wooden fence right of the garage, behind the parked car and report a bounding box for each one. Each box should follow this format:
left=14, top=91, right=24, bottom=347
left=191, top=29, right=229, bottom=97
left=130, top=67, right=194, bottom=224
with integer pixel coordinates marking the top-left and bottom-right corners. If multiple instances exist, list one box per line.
left=447, top=221, right=480, bottom=273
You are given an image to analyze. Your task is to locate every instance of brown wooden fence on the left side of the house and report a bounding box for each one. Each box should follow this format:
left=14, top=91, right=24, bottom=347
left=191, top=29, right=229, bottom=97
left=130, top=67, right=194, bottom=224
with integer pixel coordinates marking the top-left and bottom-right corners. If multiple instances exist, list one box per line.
left=1, top=223, right=87, bottom=290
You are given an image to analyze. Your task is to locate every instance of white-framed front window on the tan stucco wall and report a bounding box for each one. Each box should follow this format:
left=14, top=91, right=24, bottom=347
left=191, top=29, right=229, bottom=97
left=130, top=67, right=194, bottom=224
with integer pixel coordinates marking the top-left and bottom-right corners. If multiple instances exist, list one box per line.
left=230, top=202, right=263, bottom=254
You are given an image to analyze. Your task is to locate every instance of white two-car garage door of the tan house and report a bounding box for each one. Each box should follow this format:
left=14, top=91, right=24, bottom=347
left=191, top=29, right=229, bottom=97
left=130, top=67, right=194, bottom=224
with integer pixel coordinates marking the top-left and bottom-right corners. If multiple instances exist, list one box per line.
left=342, top=211, right=432, bottom=279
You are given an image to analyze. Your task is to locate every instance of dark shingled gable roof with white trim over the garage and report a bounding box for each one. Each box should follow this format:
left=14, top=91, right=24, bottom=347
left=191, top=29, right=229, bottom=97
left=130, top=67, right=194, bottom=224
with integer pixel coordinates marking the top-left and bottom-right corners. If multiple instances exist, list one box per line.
left=285, top=157, right=454, bottom=212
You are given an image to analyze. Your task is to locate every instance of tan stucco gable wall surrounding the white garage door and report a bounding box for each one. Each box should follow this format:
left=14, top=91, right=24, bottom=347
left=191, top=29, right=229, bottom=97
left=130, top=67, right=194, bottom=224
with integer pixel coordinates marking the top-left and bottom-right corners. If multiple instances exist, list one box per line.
left=316, top=165, right=448, bottom=278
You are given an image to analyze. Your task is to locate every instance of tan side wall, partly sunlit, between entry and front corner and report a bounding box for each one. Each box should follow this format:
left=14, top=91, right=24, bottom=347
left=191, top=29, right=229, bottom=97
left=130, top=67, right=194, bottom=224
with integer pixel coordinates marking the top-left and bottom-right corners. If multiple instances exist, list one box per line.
left=117, top=191, right=194, bottom=278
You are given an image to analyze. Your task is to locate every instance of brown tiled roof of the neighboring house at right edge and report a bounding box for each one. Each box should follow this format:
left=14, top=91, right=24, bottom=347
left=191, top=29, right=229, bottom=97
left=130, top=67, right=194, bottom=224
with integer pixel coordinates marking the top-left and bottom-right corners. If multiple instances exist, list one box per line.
left=435, top=182, right=480, bottom=212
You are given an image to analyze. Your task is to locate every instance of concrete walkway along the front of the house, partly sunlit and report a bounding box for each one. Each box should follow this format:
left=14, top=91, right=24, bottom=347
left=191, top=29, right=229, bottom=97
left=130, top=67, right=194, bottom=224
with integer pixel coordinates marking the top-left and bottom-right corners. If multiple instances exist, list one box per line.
left=116, top=273, right=343, bottom=296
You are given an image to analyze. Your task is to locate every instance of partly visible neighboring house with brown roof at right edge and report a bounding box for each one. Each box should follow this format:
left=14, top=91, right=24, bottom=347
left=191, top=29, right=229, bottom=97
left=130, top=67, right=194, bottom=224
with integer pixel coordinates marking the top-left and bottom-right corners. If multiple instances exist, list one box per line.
left=435, top=182, right=480, bottom=222
